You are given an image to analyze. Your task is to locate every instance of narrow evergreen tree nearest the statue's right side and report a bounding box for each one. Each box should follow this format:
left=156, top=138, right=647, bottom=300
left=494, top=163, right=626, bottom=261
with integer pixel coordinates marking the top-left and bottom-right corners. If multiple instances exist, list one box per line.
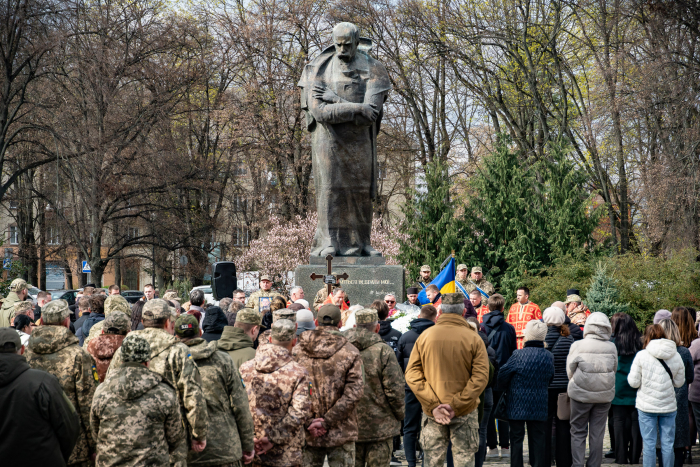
left=398, top=159, right=460, bottom=278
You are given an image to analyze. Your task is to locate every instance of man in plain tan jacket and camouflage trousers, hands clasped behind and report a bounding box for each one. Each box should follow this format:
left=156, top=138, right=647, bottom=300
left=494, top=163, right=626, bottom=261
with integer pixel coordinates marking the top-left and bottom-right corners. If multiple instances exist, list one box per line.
left=406, top=294, right=489, bottom=467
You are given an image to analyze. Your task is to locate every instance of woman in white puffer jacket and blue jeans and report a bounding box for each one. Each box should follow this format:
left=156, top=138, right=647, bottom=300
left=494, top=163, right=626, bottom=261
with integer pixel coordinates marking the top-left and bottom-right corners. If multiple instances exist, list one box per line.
left=627, top=324, right=685, bottom=467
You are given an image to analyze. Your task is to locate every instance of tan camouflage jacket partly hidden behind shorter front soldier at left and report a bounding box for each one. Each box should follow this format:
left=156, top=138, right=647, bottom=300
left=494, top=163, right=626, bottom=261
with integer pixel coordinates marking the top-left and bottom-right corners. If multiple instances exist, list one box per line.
left=106, top=328, right=209, bottom=440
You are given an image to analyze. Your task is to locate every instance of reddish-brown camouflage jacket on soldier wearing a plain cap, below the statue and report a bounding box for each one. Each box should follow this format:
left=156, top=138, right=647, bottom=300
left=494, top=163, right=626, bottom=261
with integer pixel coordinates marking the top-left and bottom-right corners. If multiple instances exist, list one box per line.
left=293, top=326, right=364, bottom=447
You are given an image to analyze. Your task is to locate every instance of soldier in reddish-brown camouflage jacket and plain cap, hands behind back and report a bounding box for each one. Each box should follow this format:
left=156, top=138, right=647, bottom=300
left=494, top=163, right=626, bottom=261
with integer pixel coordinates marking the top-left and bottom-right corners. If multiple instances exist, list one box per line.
left=293, top=305, right=364, bottom=467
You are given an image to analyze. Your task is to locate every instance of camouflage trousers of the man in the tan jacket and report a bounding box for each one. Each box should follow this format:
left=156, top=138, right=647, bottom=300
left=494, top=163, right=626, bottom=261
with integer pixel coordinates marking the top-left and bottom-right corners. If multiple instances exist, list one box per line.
left=420, top=410, right=479, bottom=467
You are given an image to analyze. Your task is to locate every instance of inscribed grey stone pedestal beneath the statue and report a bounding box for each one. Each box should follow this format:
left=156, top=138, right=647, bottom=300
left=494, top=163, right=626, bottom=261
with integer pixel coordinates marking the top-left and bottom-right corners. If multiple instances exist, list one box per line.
left=294, top=256, right=406, bottom=306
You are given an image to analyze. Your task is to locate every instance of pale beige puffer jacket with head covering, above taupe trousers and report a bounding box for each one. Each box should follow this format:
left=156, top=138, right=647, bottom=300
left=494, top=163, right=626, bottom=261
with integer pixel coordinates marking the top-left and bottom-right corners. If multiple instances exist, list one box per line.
left=566, top=313, right=617, bottom=404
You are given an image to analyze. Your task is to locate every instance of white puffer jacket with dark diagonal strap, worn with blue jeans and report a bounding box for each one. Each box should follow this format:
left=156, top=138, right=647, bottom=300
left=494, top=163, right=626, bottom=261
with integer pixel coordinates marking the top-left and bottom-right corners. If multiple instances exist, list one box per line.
left=627, top=339, right=685, bottom=413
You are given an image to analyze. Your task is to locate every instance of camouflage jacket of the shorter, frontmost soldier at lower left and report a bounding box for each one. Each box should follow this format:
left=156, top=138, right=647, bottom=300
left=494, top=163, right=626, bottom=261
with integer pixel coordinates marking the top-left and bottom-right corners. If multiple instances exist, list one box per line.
left=90, top=362, right=185, bottom=467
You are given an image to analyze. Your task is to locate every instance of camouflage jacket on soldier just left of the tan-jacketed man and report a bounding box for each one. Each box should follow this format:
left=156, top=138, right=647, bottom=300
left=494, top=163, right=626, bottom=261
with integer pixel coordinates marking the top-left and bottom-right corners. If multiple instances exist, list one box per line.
left=346, top=328, right=406, bottom=442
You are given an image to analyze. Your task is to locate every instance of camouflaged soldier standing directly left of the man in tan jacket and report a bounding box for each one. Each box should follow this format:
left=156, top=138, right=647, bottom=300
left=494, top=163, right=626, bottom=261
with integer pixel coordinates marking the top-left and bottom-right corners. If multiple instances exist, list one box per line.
left=346, top=309, right=406, bottom=467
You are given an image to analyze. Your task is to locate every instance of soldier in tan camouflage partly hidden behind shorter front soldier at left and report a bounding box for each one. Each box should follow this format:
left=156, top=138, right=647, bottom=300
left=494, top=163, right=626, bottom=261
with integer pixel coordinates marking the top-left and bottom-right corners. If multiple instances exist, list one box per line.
left=106, top=298, right=209, bottom=466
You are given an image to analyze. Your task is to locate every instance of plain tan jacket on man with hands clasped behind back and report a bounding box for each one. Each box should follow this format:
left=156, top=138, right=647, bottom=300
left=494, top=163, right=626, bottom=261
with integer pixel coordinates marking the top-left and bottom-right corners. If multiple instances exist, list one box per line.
left=406, top=313, right=489, bottom=417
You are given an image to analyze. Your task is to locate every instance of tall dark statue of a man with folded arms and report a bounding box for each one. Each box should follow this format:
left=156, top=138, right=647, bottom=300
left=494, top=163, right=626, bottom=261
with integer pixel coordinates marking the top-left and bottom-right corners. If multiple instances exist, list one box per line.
left=299, top=23, right=391, bottom=256
